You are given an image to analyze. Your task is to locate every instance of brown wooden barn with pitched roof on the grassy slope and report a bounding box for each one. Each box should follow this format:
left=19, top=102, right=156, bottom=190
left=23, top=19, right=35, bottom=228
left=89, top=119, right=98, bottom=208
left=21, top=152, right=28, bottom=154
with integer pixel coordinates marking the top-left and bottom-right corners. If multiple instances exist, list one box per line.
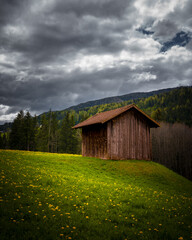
left=73, top=104, right=160, bottom=160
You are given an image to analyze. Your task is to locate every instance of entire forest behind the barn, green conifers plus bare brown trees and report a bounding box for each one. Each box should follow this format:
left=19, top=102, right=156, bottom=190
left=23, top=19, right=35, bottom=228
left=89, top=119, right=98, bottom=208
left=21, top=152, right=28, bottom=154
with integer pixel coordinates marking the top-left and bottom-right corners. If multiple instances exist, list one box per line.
left=0, top=87, right=192, bottom=178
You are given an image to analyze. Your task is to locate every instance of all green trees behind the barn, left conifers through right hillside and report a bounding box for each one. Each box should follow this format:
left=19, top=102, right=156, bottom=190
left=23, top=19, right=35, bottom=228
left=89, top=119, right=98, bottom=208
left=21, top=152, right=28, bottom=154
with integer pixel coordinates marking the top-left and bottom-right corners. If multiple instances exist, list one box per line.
left=0, top=87, right=192, bottom=153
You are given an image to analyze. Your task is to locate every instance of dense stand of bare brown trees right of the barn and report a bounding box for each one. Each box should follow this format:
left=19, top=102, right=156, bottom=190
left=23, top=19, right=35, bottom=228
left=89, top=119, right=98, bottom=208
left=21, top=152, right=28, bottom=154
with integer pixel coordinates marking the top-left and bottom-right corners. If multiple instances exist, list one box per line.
left=151, top=122, right=192, bottom=180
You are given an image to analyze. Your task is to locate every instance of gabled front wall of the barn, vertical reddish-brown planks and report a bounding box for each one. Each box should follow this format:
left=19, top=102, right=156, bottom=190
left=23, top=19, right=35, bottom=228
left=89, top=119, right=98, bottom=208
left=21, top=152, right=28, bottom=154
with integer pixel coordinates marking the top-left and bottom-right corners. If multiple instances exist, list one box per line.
left=107, top=110, right=151, bottom=160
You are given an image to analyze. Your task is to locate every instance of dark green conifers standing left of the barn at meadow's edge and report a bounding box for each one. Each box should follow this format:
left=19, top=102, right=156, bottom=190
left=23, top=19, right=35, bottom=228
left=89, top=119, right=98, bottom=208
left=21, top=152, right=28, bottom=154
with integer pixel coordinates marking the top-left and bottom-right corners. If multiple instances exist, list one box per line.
left=0, top=110, right=81, bottom=153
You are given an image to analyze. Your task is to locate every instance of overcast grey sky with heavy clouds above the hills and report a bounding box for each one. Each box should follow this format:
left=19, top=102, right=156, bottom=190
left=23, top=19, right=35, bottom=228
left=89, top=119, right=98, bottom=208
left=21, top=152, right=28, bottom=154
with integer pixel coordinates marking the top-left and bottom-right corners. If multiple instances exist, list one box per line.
left=0, top=0, right=192, bottom=124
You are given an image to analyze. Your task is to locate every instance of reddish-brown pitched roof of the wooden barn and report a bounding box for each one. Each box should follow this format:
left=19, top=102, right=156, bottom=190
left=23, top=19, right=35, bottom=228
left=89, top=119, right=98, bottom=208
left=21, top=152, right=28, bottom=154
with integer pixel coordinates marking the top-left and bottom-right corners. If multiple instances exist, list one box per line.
left=73, top=104, right=160, bottom=128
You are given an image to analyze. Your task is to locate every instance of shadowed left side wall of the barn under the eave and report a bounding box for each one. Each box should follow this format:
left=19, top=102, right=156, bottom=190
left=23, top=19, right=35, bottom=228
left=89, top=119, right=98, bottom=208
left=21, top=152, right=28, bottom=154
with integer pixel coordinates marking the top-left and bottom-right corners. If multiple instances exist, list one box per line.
left=82, top=124, right=107, bottom=159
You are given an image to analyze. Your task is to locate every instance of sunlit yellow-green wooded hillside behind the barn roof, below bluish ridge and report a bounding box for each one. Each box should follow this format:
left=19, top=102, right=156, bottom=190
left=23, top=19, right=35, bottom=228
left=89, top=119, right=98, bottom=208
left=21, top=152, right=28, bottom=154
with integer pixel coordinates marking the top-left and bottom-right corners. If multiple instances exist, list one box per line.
left=48, top=87, right=192, bottom=126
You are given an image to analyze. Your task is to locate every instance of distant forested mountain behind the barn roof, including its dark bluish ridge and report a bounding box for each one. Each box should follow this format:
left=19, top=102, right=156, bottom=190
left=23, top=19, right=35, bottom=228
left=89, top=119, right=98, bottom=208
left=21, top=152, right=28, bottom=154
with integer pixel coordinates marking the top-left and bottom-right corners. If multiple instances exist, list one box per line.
left=0, top=87, right=192, bottom=132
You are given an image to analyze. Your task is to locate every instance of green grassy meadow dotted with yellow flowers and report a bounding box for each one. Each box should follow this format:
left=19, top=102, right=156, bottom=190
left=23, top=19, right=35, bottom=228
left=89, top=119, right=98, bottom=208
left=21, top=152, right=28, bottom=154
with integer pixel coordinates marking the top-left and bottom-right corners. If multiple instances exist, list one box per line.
left=0, top=150, right=192, bottom=240
